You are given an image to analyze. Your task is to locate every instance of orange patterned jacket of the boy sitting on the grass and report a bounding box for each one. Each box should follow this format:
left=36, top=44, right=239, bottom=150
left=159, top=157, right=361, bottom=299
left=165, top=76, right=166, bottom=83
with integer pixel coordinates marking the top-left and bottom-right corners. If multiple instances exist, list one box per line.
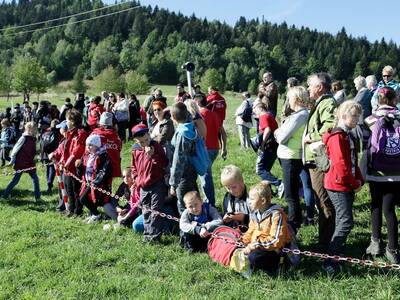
left=242, top=205, right=291, bottom=251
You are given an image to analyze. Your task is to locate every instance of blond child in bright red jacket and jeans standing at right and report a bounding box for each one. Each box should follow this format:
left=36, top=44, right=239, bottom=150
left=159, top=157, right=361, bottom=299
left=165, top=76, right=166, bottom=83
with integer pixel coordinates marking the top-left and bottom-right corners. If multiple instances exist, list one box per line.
left=322, top=101, right=363, bottom=273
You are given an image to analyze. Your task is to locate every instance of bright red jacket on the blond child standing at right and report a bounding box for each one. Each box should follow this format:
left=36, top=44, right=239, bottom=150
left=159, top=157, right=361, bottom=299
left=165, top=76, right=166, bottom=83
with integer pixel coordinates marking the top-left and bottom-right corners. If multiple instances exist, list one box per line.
left=322, top=129, right=364, bottom=192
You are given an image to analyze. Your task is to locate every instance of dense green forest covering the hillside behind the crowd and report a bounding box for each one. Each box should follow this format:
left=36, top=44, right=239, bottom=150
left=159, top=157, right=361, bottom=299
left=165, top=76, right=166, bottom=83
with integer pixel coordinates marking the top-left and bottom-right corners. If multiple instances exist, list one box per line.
left=0, top=0, right=400, bottom=96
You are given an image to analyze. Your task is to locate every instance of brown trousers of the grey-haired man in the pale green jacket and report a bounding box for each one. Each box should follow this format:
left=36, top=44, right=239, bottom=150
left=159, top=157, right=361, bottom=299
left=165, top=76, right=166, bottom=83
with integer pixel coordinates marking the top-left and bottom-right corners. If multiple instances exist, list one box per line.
left=310, top=169, right=335, bottom=251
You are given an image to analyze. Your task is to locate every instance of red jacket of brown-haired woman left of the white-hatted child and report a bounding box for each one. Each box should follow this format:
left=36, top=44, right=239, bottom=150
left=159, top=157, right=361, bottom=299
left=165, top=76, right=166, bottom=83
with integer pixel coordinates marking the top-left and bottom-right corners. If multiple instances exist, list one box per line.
left=53, top=128, right=89, bottom=174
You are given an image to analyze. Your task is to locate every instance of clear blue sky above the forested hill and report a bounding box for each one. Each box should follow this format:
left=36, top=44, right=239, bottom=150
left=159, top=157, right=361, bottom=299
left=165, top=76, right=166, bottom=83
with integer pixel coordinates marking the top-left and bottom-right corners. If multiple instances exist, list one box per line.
left=131, top=0, right=400, bottom=45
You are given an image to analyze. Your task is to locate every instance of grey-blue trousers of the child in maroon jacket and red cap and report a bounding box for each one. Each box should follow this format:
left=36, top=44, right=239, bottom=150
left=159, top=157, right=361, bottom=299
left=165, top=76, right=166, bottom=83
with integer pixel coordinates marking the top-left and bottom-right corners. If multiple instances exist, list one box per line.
left=140, top=180, right=167, bottom=241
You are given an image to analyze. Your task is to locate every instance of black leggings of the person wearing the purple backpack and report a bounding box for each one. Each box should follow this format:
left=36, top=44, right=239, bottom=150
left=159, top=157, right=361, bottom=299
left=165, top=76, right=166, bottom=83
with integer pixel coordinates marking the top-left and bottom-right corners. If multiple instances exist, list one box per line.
left=369, top=182, right=400, bottom=250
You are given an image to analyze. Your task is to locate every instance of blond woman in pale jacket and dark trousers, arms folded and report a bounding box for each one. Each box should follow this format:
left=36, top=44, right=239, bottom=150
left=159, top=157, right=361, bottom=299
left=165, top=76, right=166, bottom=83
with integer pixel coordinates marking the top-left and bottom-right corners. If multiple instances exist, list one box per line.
left=275, top=86, right=312, bottom=232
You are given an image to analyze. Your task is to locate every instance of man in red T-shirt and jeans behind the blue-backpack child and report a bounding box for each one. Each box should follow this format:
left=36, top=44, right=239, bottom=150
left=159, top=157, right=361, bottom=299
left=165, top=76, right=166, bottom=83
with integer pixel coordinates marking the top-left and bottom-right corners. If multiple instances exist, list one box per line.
left=194, top=94, right=221, bottom=206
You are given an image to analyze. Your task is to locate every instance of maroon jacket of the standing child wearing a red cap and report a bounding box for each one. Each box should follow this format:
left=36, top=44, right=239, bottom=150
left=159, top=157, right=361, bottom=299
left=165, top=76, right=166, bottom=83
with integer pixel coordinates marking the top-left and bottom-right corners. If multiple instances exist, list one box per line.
left=132, top=141, right=168, bottom=188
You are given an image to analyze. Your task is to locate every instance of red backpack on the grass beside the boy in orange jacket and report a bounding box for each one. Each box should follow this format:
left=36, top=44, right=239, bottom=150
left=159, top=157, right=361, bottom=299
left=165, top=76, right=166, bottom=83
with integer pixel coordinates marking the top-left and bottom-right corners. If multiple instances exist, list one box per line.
left=207, top=226, right=242, bottom=266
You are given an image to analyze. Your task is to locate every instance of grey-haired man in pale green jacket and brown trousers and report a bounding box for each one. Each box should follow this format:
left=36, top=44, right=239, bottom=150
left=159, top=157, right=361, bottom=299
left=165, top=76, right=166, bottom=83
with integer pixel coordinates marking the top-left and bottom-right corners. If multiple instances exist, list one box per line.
left=303, top=73, right=336, bottom=251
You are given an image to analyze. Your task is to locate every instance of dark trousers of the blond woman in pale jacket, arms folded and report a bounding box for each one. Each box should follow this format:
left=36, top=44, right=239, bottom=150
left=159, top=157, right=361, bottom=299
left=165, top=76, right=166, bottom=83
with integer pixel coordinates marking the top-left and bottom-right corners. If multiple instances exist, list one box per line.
left=281, top=159, right=303, bottom=231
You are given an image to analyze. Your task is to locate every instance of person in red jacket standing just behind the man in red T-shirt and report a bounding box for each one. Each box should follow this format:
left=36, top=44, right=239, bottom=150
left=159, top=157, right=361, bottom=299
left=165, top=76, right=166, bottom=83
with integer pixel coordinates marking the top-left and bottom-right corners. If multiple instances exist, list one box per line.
left=207, top=86, right=227, bottom=159
